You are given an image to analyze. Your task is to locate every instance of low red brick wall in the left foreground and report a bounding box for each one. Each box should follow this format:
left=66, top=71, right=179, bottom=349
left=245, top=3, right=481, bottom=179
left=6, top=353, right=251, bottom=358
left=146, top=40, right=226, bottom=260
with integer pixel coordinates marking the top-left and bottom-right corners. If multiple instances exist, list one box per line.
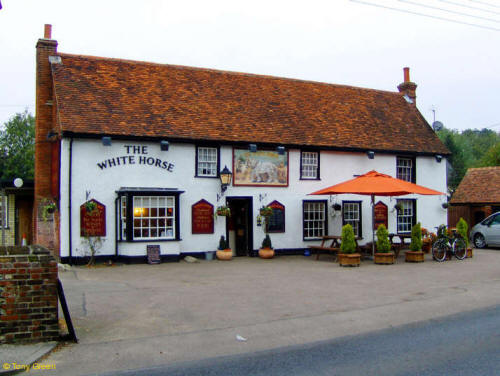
left=0, top=246, right=59, bottom=343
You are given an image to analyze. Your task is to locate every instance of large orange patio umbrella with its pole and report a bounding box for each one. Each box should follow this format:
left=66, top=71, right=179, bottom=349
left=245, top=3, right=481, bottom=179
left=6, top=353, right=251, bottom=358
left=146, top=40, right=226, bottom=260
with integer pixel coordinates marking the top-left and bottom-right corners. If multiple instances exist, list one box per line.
left=310, top=170, right=445, bottom=253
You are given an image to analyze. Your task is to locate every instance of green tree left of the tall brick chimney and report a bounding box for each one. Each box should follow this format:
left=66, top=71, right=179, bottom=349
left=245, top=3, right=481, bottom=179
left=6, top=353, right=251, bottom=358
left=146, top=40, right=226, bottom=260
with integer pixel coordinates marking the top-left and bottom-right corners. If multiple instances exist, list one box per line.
left=0, top=110, right=35, bottom=180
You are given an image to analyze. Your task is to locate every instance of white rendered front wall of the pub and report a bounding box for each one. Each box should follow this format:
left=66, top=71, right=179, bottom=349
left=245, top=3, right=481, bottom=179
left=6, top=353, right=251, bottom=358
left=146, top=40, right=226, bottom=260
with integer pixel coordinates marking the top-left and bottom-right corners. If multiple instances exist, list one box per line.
left=60, top=139, right=446, bottom=257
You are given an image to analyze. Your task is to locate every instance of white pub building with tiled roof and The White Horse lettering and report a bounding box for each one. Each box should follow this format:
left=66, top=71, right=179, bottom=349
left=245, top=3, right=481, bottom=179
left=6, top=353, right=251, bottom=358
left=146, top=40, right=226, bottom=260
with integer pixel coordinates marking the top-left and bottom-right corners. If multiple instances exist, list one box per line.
left=35, top=25, right=449, bottom=262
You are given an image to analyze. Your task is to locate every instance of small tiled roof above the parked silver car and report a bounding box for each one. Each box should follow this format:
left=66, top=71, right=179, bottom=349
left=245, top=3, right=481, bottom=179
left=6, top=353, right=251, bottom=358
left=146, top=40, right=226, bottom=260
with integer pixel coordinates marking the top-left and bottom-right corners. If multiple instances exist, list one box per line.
left=450, top=166, right=500, bottom=205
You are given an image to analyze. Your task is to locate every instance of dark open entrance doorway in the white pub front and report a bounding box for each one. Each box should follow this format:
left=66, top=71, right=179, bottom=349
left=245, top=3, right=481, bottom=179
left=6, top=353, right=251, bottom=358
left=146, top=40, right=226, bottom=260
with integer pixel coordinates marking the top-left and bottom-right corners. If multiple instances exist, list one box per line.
left=226, top=197, right=253, bottom=256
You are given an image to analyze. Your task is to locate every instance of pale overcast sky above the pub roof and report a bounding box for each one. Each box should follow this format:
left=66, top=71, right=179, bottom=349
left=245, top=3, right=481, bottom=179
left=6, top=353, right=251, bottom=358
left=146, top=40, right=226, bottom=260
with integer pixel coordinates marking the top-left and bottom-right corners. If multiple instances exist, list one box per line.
left=0, top=0, right=500, bottom=131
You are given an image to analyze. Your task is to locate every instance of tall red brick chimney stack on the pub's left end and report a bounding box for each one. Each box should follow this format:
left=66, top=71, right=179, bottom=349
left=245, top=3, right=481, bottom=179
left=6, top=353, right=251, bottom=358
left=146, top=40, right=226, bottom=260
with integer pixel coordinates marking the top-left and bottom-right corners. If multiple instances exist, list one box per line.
left=33, top=25, right=60, bottom=256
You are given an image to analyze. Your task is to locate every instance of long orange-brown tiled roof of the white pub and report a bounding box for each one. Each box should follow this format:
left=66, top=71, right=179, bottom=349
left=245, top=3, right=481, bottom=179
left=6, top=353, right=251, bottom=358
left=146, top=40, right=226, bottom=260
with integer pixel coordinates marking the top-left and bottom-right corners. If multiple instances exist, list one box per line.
left=52, top=54, right=448, bottom=154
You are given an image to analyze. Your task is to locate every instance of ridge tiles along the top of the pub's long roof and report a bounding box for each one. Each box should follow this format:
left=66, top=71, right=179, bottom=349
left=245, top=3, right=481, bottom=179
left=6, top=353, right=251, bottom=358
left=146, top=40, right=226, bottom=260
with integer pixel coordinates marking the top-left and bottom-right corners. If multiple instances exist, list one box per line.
left=58, top=52, right=403, bottom=98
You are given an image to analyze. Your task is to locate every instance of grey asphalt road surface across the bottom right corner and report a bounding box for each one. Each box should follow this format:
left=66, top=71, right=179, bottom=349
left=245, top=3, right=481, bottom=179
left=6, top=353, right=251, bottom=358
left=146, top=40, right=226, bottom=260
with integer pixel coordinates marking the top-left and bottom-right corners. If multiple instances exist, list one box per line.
left=98, top=306, right=500, bottom=376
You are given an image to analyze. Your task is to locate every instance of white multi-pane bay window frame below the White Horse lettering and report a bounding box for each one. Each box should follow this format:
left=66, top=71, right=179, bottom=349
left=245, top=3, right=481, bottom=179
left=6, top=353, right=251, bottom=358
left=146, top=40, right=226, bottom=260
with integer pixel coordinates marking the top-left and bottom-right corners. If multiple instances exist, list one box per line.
left=132, top=195, right=176, bottom=241
